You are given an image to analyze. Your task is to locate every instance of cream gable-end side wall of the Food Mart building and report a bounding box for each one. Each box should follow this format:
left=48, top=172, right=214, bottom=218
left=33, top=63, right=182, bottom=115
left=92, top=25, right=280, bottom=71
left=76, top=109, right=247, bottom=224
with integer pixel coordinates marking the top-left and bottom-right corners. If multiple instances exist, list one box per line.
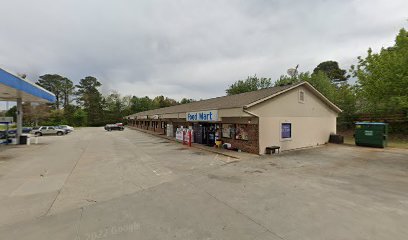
left=249, top=86, right=337, bottom=154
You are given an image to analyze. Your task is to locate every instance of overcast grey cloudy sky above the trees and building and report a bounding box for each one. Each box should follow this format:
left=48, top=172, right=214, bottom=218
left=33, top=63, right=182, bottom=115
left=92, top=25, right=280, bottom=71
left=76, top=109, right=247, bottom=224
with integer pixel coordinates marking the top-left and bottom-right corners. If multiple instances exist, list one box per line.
left=0, top=0, right=408, bottom=105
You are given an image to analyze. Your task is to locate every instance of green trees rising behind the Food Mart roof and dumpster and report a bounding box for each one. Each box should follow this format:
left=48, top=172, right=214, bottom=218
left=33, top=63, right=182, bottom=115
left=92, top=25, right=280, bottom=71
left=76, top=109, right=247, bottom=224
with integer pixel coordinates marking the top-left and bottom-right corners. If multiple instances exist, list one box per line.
left=226, top=29, right=408, bottom=134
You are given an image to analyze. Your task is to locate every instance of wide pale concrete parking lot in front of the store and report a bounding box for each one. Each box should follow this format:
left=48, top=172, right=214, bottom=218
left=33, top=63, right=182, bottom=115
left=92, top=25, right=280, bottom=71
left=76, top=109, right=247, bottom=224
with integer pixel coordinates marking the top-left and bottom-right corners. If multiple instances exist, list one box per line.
left=0, top=128, right=408, bottom=240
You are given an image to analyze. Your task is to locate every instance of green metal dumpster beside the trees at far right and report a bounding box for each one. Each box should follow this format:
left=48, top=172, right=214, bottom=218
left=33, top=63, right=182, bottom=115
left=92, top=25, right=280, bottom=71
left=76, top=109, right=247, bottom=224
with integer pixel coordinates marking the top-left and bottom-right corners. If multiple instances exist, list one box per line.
left=354, top=122, right=388, bottom=148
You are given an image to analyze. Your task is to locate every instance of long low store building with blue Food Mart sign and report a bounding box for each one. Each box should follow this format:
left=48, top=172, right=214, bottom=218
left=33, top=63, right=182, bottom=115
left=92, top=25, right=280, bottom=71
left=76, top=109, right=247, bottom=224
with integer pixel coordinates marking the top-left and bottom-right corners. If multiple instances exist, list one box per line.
left=127, top=82, right=341, bottom=154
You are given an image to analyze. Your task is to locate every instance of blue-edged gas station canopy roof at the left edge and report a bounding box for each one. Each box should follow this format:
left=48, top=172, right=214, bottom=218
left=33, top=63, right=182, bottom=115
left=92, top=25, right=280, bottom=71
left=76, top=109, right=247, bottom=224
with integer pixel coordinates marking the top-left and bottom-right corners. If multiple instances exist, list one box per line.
left=0, top=68, right=56, bottom=103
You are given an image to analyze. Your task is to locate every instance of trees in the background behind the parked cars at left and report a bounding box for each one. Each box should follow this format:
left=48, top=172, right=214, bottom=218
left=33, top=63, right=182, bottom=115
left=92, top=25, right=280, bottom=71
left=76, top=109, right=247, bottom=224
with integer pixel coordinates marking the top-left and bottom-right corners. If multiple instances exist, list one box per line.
left=6, top=74, right=194, bottom=126
